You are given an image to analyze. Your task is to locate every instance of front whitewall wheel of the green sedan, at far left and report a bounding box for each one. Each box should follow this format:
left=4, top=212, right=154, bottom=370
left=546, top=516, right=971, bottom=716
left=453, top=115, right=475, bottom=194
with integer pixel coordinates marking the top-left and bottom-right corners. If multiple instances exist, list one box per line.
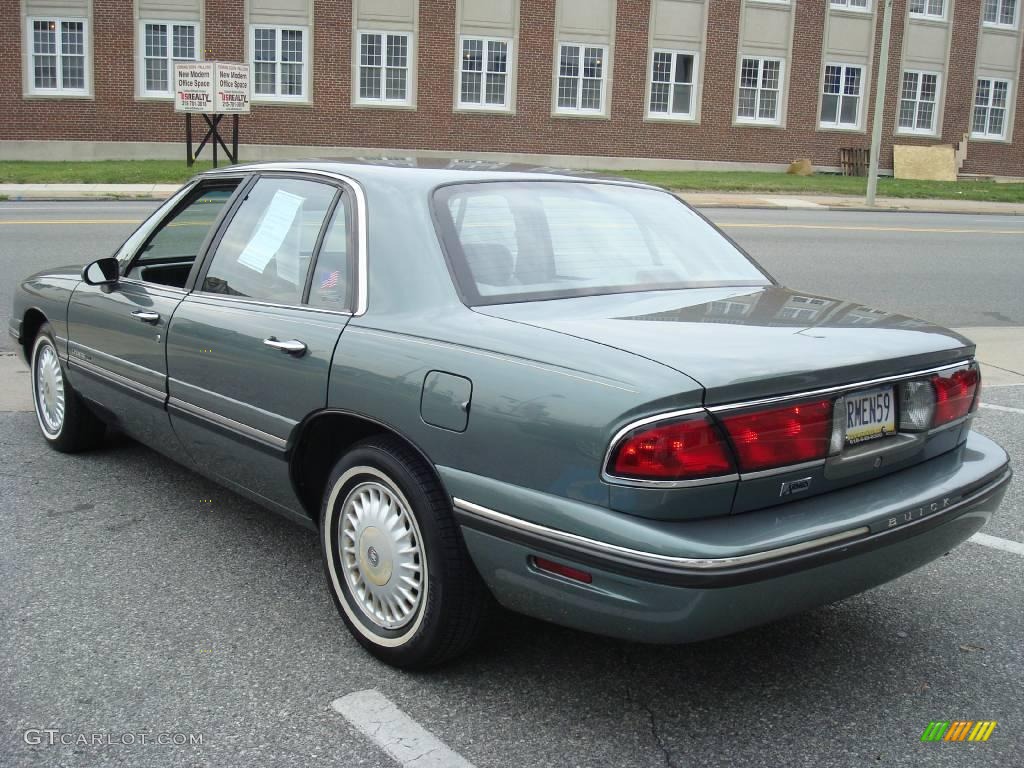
left=32, top=323, right=105, bottom=454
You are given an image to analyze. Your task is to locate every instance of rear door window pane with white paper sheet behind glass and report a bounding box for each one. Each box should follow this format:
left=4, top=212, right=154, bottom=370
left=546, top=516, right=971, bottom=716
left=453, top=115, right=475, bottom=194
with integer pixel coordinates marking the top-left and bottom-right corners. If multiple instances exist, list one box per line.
left=202, top=178, right=339, bottom=304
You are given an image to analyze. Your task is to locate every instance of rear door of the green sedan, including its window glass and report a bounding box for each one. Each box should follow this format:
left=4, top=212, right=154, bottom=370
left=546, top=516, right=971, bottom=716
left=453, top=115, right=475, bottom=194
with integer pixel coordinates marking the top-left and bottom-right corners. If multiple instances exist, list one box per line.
left=167, top=174, right=351, bottom=514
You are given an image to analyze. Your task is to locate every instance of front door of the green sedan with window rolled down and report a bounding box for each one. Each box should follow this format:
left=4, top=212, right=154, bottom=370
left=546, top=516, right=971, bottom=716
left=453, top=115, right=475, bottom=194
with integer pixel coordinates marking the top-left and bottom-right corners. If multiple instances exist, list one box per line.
left=68, top=180, right=239, bottom=453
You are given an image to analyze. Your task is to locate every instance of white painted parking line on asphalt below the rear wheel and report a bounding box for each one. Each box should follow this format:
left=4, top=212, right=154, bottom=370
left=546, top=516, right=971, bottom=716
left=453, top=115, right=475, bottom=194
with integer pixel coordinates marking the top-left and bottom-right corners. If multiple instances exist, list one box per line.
left=331, top=689, right=473, bottom=768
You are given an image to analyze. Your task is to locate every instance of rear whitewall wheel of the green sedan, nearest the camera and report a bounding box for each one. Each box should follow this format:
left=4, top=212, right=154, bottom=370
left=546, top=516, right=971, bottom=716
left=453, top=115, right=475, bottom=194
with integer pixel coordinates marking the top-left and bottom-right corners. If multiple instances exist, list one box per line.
left=321, top=436, right=489, bottom=668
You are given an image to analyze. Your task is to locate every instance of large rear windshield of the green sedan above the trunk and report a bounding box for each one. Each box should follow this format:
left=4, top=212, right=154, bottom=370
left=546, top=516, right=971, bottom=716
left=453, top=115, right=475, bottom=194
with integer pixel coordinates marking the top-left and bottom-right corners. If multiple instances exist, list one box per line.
left=434, top=181, right=770, bottom=305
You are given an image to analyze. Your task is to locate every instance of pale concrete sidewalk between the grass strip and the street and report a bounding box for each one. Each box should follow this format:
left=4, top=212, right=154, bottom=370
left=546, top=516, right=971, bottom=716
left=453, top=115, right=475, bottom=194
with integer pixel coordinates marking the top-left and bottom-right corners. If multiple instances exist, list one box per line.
left=0, top=184, right=1024, bottom=216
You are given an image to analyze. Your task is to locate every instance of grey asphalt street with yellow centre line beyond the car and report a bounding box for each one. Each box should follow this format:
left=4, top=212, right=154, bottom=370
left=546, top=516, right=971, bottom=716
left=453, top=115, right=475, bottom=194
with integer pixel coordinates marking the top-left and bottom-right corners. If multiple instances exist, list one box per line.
left=0, top=202, right=1024, bottom=348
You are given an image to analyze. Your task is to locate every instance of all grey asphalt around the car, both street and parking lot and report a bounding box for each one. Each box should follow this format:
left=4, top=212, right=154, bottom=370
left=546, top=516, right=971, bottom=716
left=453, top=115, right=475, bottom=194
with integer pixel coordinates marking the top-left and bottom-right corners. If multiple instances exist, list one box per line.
left=0, top=203, right=1024, bottom=768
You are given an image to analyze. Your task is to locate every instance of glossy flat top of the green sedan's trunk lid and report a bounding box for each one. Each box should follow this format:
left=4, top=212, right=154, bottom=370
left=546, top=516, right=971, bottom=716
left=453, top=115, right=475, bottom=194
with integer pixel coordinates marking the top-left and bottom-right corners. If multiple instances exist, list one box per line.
left=476, top=286, right=974, bottom=404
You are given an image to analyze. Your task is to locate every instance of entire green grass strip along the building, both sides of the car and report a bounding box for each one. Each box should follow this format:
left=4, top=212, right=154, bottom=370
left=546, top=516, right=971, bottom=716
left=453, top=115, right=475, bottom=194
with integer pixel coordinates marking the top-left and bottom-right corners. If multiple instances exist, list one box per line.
left=0, top=160, right=1024, bottom=203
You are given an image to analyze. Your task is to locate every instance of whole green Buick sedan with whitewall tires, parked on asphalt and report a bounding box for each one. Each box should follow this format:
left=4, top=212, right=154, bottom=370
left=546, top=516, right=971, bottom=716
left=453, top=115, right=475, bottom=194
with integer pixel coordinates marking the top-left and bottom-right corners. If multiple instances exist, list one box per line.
left=10, top=161, right=1011, bottom=668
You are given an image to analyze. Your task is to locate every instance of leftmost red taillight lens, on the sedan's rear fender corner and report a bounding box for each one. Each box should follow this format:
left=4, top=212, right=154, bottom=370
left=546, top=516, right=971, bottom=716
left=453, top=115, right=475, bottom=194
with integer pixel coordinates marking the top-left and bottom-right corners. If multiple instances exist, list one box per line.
left=608, top=416, right=734, bottom=480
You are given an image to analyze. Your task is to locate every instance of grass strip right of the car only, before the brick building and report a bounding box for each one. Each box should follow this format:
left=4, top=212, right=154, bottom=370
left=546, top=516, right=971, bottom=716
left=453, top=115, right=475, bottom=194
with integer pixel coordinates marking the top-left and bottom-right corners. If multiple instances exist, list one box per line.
left=608, top=171, right=1024, bottom=203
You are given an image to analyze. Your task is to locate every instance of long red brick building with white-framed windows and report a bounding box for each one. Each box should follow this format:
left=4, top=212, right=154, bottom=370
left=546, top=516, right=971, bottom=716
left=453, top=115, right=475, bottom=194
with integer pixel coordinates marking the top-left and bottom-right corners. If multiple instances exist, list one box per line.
left=0, top=0, right=1024, bottom=176
